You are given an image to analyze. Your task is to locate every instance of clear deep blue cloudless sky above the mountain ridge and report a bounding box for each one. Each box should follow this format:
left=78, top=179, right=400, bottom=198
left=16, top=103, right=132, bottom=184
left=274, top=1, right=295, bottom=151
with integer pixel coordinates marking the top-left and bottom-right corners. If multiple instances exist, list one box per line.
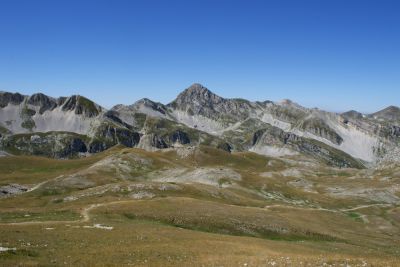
left=0, top=0, right=400, bottom=112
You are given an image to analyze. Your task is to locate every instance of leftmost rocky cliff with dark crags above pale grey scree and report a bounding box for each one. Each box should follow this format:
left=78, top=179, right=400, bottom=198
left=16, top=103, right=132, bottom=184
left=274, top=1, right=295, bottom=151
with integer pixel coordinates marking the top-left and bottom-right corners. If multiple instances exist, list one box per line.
left=0, top=93, right=104, bottom=135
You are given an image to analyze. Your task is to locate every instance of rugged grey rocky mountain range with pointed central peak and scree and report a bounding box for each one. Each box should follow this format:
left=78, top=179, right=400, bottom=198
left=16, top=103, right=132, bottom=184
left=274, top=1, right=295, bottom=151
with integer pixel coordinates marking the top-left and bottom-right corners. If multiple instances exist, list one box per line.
left=0, top=84, right=400, bottom=168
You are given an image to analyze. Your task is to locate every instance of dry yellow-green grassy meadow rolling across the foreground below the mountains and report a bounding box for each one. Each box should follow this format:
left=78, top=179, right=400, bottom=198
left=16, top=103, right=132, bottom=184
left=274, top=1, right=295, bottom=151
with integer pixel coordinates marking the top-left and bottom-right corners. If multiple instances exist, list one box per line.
left=0, top=147, right=400, bottom=266
